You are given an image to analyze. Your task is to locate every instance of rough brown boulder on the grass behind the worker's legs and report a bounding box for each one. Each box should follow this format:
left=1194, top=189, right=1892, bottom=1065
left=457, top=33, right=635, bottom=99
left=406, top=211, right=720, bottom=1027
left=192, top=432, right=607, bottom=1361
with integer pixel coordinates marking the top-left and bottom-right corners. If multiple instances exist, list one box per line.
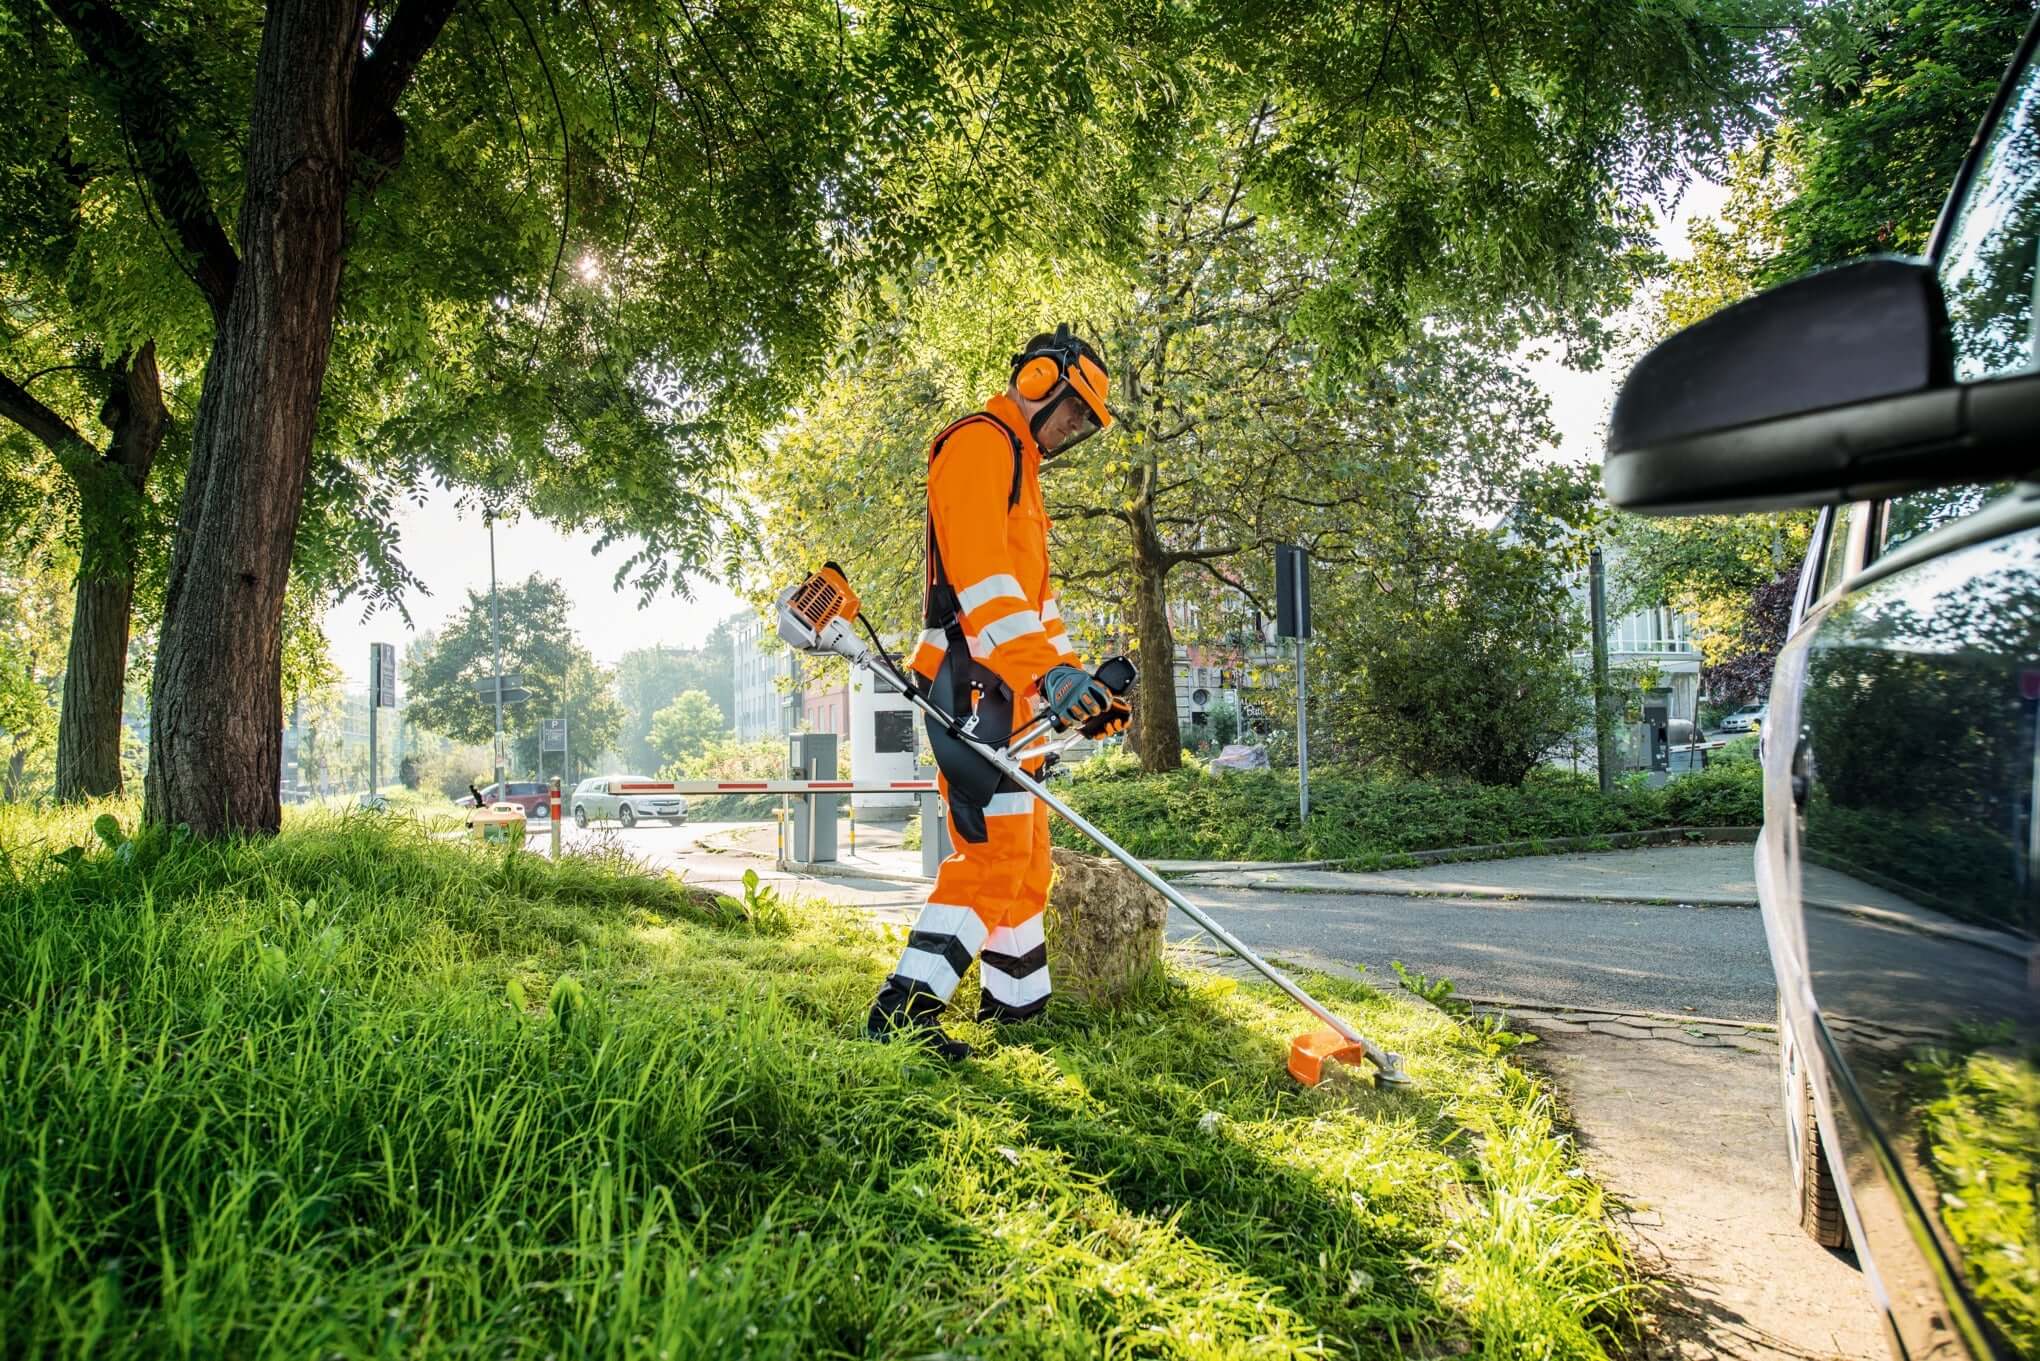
left=1042, top=847, right=1169, bottom=1006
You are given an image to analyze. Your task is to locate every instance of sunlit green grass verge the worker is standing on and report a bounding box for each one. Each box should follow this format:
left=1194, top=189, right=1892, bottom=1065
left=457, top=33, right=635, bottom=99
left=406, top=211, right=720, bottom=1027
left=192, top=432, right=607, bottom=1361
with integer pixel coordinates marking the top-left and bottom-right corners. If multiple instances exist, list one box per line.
left=0, top=814, right=1634, bottom=1359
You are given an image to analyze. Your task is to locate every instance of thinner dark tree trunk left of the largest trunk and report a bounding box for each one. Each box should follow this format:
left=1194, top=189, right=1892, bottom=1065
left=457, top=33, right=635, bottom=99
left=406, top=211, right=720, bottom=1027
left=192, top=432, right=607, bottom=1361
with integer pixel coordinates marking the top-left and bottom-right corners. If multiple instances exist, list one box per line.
left=57, top=343, right=165, bottom=802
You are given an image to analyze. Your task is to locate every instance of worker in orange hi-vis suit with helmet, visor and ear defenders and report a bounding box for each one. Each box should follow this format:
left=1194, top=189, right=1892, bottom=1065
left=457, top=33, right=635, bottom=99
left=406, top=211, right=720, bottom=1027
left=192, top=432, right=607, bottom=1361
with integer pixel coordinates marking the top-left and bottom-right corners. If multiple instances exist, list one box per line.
left=865, top=326, right=1128, bottom=1059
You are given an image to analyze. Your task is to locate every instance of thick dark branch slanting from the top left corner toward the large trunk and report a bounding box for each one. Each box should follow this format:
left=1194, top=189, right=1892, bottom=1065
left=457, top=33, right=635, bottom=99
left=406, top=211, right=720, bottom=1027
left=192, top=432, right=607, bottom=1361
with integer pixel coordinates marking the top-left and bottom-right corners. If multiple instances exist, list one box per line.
left=49, top=0, right=241, bottom=316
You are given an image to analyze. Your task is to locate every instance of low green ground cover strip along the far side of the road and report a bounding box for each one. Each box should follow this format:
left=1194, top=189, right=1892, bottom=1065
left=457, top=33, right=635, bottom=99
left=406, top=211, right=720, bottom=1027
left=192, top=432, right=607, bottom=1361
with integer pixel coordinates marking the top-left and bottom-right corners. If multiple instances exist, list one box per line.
left=1053, top=757, right=1763, bottom=869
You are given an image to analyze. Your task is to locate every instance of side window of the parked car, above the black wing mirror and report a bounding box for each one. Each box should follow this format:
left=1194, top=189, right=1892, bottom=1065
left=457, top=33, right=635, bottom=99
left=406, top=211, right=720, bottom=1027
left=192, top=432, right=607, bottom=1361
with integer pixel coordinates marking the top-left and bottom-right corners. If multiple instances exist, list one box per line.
left=1936, top=50, right=2040, bottom=384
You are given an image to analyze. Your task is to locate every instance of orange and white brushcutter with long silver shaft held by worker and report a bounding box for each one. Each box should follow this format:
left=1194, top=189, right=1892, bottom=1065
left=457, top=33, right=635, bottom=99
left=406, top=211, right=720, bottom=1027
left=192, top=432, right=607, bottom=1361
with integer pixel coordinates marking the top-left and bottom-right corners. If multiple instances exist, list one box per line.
left=779, top=563, right=1412, bottom=1088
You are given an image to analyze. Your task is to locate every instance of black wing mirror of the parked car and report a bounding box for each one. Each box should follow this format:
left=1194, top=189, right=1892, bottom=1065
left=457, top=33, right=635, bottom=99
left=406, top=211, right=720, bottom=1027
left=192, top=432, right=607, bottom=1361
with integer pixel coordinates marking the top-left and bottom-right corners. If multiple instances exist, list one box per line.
left=1601, top=257, right=2040, bottom=514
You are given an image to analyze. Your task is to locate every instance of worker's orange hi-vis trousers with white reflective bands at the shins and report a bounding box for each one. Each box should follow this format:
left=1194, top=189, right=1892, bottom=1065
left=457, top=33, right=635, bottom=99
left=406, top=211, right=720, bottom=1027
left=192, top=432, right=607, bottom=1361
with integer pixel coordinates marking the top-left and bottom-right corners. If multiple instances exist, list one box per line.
left=891, top=779, right=1051, bottom=1020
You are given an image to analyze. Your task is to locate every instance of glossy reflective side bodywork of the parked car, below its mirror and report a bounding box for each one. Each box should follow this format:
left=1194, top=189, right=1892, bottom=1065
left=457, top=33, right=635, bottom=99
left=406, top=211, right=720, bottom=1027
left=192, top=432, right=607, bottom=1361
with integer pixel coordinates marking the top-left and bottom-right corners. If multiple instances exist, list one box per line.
left=1763, top=516, right=2040, bottom=1357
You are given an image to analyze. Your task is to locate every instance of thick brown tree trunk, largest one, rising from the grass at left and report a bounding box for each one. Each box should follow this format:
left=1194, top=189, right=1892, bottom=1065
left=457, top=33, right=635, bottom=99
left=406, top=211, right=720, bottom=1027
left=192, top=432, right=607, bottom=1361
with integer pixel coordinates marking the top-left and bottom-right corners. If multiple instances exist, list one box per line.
left=147, top=0, right=361, bottom=837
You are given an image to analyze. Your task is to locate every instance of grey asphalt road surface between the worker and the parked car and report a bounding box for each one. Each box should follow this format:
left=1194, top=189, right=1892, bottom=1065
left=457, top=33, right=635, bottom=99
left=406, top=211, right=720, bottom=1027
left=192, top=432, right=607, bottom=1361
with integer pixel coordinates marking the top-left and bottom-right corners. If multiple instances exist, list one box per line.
left=1171, top=890, right=1777, bottom=1020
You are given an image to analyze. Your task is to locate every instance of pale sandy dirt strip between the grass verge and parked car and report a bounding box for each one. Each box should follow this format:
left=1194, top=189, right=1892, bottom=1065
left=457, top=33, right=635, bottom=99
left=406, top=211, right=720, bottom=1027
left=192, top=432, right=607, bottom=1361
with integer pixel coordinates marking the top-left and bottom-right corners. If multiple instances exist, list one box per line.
left=1518, top=1026, right=1887, bottom=1361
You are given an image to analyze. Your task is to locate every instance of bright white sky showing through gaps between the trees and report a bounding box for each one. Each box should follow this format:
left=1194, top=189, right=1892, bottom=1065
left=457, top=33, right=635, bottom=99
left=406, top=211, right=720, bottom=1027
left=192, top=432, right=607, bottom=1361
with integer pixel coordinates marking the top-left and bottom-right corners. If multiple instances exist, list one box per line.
left=326, top=182, right=1726, bottom=686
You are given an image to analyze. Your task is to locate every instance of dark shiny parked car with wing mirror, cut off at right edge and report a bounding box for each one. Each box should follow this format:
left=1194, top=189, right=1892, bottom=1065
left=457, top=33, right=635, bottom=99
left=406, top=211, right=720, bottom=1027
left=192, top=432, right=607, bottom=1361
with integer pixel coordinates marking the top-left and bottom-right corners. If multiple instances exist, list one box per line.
left=1603, top=21, right=2040, bottom=1359
